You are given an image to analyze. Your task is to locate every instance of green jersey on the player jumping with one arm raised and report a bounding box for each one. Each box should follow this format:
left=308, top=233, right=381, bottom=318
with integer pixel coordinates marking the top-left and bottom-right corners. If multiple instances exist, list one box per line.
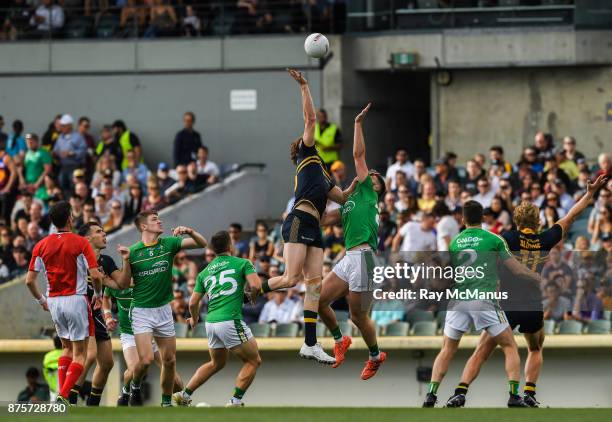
left=340, top=175, right=378, bottom=250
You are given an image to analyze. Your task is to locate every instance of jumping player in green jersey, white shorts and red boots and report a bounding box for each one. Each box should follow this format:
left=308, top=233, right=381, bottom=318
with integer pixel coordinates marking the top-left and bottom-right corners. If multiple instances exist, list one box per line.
left=319, top=104, right=387, bottom=380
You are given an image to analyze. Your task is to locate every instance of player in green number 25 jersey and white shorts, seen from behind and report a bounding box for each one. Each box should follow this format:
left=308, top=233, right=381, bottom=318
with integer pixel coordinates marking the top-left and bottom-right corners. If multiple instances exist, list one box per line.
left=172, top=231, right=261, bottom=407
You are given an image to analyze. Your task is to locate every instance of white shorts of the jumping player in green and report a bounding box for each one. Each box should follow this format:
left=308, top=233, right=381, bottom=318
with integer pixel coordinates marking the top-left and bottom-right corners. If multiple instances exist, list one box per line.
left=332, top=248, right=376, bottom=292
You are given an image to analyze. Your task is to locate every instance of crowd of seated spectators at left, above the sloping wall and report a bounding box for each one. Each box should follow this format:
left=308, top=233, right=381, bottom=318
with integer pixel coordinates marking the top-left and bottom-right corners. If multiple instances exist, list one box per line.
left=0, top=112, right=220, bottom=283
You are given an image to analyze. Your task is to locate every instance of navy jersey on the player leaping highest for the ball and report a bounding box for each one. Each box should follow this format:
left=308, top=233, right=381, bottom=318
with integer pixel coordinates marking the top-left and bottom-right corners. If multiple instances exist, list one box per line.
left=294, top=141, right=334, bottom=216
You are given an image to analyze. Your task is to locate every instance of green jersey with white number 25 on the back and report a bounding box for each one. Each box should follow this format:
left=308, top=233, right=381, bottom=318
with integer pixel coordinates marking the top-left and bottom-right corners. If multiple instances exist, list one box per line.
left=194, top=255, right=255, bottom=322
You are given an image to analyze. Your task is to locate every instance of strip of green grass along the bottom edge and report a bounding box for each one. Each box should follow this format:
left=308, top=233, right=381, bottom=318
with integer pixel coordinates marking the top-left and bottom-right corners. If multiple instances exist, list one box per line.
left=0, top=407, right=612, bottom=422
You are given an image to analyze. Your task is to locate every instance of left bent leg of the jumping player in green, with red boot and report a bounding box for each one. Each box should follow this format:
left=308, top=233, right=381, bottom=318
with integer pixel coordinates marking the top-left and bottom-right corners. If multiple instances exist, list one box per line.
left=319, top=269, right=352, bottom=368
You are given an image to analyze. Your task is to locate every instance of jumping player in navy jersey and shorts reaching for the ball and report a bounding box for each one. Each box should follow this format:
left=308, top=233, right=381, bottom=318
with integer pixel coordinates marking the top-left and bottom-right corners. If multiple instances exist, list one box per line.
left=262, top=69, right=355, bottom=365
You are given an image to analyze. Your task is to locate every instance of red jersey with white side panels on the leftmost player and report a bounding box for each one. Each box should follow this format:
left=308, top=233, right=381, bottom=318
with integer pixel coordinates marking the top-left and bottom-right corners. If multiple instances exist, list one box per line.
left=29, top=232, right=98, bottom=297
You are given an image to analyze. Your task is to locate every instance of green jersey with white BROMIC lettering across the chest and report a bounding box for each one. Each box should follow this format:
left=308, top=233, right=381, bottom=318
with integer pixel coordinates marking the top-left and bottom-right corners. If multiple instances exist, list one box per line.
left=130, top=236, right=183, bottom=308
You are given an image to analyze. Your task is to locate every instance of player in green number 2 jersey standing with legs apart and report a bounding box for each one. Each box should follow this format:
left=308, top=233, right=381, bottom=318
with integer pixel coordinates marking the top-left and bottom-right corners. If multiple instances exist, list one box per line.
left=423, top=201, right=540, bottom=407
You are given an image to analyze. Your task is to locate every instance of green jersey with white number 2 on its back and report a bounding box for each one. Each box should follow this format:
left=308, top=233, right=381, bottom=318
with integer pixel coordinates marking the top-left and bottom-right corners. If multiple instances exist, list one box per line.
left=449, top=228, right=512, bottom=293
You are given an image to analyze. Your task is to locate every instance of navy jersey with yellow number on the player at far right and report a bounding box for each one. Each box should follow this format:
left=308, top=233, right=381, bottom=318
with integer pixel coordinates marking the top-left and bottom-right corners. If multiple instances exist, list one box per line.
left=501, top=224, right=563, bottom=311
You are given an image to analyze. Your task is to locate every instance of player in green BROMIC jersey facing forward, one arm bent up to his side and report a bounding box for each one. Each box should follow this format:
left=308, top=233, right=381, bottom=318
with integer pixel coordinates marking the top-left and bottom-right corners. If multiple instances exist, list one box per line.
left=121, top=211, right=206, bottom=407
